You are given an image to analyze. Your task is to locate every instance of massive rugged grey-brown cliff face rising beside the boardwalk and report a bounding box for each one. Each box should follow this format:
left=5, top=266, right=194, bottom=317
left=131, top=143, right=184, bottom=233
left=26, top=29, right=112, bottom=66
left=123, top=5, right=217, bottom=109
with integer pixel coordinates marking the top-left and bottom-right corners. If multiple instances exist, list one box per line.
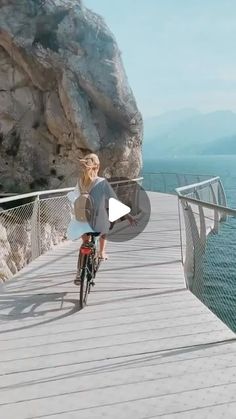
left=0, top=0, right=142, bottom=191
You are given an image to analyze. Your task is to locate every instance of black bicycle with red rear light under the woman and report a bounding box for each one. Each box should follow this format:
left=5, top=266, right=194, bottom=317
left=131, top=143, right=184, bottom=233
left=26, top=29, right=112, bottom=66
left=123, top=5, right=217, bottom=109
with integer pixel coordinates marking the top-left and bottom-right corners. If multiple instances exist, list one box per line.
left=76, top=233, right=101, bottom=309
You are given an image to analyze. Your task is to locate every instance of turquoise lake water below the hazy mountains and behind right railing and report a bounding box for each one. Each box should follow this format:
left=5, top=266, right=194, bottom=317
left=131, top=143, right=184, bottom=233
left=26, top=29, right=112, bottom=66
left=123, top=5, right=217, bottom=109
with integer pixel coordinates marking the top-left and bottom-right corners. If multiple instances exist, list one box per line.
left=143, top=156, right=236, bottom=332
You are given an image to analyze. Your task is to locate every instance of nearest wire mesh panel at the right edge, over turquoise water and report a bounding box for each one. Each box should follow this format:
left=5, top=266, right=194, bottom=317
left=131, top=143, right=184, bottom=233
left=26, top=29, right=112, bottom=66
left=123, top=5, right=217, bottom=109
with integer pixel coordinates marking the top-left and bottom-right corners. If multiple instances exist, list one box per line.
left=190, top=212, right=236, bottom=332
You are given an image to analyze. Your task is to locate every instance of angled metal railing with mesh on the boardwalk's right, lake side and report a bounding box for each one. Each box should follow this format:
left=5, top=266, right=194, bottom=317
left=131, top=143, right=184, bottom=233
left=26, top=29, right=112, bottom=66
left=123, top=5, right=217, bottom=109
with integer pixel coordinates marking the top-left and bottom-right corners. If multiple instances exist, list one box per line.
left=176, top=177, right=236, bottom=331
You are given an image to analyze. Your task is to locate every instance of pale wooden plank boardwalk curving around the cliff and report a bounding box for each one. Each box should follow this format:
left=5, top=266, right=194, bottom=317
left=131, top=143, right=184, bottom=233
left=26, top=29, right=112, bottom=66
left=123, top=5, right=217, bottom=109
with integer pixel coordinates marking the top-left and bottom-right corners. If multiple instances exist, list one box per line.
left=0, top=193, right=236, bottom=419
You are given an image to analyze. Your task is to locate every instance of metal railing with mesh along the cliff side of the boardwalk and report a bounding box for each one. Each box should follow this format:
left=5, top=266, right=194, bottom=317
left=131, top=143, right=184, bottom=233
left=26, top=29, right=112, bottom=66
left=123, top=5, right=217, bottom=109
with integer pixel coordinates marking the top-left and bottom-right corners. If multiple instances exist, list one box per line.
left=0, top=177, right=142, bottom=281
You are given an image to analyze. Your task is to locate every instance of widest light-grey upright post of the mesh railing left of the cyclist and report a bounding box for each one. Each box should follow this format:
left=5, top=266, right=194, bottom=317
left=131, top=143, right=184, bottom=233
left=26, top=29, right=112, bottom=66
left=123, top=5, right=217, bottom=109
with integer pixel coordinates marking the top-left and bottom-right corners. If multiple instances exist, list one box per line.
left=31, top=195, right=41, bottom=260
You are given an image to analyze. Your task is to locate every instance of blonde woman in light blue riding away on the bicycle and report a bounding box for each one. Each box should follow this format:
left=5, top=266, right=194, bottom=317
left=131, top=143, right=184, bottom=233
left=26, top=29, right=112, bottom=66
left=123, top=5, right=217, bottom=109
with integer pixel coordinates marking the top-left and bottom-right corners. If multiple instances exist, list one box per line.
left=67, top=153, right=136, bottom=274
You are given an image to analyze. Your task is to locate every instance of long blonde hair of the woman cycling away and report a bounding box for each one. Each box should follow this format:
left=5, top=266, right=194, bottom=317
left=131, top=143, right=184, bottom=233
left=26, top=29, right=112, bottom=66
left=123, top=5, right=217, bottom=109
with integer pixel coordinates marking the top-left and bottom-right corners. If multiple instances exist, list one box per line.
left=78, top=153, right=100, bottom=192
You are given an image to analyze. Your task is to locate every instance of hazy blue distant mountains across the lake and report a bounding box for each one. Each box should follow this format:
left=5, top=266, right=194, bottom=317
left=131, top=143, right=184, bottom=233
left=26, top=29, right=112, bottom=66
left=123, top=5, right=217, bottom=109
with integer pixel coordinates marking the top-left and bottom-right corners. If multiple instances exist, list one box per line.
left=143, top=109, right=236, bottom=158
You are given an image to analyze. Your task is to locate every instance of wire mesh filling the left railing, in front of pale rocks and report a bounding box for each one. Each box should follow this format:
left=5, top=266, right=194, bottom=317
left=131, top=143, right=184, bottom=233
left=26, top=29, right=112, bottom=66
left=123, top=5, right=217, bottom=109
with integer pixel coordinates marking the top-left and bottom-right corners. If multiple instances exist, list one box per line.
left=0, top=195, right=72, bottom=281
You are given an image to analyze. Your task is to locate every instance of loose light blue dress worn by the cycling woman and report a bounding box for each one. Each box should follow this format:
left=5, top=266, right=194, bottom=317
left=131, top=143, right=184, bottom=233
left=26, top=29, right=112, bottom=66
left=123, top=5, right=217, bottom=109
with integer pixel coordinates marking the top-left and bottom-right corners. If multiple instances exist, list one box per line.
left=67, top=177, right=117, bottom=240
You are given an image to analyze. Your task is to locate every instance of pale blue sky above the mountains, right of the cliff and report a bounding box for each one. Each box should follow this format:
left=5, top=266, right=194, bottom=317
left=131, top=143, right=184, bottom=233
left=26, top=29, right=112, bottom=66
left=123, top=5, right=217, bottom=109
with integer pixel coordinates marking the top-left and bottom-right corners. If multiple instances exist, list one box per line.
left=84, top=0, right=236, bottom=118
